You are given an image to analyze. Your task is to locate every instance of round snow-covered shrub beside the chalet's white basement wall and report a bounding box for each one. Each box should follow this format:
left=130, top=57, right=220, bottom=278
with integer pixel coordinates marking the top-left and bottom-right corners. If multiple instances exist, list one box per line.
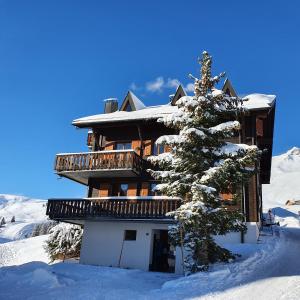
left=45, top=223, right=83, bottom=261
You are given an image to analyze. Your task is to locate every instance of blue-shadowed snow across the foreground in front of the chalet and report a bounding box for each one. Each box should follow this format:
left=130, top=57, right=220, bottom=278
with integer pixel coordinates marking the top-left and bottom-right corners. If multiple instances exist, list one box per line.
left=0, top=233, right=284, bottom=300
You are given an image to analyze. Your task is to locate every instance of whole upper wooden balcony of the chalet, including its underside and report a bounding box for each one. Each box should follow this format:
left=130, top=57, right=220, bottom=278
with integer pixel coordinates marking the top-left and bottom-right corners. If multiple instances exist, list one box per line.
left=54, top=150, right=143, bottom=185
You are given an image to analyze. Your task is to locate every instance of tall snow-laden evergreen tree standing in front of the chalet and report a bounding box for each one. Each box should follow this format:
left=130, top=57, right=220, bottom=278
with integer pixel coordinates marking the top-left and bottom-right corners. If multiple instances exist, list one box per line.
left=149, top=52, right=260, bottom=273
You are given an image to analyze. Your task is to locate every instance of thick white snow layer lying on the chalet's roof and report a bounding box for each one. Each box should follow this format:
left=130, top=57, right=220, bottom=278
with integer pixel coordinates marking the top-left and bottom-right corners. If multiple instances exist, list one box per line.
left=72, top=94, right=276, bottom=127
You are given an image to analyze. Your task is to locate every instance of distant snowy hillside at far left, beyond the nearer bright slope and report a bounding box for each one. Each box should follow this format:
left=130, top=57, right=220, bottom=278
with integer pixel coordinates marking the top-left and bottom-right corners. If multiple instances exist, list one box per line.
left=0, top=194, right=47, bottom=243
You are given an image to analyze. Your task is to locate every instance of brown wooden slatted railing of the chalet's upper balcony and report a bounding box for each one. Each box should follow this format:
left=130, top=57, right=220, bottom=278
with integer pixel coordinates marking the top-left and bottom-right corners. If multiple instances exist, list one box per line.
left=54, top=150, right=143, bottom=173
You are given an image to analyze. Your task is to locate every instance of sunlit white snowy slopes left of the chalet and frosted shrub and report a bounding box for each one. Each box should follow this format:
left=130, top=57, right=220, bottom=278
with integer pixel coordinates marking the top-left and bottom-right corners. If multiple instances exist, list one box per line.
left=0, top=194, right=49, bottom=268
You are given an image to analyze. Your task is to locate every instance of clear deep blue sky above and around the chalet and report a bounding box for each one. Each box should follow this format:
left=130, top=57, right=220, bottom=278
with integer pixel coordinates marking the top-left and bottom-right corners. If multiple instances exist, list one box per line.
left=0, top=0, right=300, bottom=198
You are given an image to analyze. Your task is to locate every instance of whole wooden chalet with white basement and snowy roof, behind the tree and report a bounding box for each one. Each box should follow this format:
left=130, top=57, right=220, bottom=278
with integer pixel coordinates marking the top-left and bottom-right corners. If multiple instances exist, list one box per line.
left=47, top=80, right=275, bottom=273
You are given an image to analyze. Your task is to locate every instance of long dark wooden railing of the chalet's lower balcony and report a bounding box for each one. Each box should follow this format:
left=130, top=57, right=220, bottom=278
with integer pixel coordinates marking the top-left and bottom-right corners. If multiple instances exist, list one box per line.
left=46, top=197, right=181, bottom=220
